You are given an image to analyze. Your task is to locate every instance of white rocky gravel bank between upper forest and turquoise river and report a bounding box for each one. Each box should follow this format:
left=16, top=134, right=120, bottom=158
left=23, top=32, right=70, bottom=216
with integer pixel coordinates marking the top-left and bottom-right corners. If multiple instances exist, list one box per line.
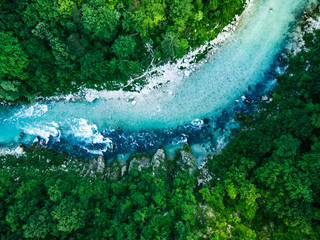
left=30, top=0, right=253, bottom=105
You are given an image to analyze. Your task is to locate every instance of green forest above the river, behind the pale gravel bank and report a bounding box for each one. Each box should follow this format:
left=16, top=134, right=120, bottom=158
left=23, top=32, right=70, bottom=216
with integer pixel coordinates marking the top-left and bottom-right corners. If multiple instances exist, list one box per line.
left=0, top=0, right=244, bottom=102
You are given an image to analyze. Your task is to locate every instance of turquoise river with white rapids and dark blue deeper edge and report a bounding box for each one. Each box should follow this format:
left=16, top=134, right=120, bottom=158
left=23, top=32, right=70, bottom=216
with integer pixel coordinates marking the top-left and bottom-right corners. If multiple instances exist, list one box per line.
left=0, top=0, right=314, bottom=159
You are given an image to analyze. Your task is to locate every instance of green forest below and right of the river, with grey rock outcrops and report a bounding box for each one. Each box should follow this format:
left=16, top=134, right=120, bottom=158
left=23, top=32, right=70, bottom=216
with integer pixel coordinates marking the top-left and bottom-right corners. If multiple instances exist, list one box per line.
left=0, top=24, right=320, bottom=240
